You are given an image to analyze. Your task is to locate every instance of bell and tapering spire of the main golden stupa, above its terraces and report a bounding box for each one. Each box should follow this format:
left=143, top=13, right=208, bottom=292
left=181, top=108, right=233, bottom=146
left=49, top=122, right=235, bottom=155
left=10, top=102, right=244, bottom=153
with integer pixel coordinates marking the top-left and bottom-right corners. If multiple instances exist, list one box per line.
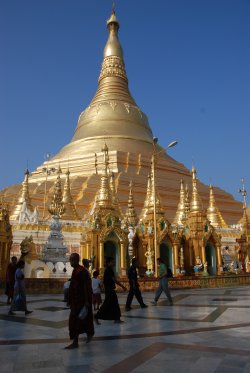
left=66, top=6, right=153, bottom=156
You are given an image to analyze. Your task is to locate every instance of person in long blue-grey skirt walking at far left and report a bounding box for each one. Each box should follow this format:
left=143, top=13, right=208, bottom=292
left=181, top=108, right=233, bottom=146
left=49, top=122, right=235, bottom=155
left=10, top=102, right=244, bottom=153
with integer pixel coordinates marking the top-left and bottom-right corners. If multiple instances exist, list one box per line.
left=8, top=260, right=33, bottom=316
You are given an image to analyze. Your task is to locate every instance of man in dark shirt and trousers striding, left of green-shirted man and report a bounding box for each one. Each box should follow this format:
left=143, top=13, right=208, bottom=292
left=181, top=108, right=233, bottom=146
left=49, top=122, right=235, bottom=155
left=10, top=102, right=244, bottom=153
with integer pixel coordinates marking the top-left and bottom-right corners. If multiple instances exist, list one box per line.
left=125, top=258, right=147, bottom=311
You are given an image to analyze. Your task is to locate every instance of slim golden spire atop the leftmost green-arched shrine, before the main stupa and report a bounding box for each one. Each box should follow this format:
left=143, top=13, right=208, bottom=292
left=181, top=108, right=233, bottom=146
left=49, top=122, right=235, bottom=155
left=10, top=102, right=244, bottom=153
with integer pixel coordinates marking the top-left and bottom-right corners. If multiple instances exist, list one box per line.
left=96, top=143, right=114, bottom=210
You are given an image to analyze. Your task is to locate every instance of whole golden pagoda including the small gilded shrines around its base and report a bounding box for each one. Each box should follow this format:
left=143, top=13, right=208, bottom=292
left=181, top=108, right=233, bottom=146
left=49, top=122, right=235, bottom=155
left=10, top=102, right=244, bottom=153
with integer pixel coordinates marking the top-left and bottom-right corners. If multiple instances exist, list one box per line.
left=0, top=7, right=246, bottom=282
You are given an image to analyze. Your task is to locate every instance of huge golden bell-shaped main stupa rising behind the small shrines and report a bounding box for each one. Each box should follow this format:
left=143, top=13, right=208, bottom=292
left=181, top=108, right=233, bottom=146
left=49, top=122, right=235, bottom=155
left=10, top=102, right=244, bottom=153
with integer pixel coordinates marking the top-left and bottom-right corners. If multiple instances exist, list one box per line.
left=1, top=9, right=241, bottom=224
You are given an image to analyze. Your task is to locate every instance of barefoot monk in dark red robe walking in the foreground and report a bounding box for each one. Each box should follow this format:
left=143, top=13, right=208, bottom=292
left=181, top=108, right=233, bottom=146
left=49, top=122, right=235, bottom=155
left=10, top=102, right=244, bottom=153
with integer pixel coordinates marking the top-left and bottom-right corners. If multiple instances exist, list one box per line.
left=65, top=253, right=95, bottom=349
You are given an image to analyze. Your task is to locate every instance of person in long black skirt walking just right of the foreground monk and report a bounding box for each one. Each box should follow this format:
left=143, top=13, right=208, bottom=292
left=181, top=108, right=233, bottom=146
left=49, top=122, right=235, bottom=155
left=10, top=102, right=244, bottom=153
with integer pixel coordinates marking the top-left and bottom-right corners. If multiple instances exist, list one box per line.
left=94, top=257, right=127, bottom=324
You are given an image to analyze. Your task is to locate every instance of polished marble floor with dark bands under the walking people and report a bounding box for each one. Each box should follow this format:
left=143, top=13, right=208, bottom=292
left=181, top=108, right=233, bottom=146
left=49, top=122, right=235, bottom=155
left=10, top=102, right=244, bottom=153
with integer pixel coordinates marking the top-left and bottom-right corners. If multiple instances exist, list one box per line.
left=0, top=286, right=250, bottom=373
